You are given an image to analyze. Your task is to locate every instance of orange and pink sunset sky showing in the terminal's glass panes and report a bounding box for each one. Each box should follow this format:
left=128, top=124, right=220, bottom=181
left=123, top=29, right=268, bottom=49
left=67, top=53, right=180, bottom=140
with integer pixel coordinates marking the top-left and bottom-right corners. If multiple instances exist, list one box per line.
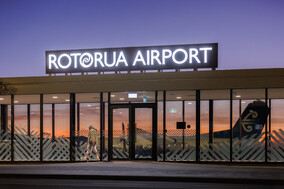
left=9, top=99, right=284, bottom=140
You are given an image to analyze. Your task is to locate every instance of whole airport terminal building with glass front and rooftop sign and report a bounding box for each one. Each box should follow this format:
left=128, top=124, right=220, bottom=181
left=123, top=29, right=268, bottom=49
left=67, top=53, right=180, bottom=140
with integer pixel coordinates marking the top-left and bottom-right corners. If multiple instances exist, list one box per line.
left=0, top=43, right=284, bottom=163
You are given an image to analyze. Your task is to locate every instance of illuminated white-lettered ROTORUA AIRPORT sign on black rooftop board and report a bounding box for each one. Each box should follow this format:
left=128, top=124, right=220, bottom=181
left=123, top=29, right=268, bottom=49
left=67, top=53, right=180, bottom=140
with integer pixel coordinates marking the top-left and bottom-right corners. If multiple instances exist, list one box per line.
left=46, top=43, right=218, bottom=73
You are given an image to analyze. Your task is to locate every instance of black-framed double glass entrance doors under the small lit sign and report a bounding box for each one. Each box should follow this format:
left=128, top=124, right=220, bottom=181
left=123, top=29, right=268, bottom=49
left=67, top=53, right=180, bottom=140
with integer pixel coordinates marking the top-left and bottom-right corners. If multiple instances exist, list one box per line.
left=108, top=103, right=157, bottom=160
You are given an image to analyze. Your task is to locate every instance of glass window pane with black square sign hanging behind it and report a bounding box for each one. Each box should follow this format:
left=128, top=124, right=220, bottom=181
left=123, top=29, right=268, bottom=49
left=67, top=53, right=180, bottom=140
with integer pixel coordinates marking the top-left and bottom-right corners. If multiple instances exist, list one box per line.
left=166, top=91, right=196, bottom=161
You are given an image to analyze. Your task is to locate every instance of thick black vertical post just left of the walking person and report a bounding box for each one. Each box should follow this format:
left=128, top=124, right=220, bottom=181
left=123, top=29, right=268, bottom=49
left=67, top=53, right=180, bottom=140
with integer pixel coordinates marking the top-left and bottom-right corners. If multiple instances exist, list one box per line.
left=70, top=93, right=76, bottom=162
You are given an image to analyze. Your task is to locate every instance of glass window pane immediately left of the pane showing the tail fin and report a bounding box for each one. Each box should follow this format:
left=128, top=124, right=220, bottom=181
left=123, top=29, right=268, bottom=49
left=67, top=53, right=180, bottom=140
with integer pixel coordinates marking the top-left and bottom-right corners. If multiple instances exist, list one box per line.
left=200, top=90, right=230, bottom=161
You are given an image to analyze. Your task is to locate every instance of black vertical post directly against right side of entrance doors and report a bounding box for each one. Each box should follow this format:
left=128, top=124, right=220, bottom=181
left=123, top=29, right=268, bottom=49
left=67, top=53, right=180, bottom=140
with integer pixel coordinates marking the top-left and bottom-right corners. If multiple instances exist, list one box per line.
left=152, top=91, right=158, bottom=161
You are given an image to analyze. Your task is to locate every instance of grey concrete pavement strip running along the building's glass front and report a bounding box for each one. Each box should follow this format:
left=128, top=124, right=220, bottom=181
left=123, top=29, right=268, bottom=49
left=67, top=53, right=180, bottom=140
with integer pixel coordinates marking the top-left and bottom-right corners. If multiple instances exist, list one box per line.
left=0, top=161, right=284, bottom=185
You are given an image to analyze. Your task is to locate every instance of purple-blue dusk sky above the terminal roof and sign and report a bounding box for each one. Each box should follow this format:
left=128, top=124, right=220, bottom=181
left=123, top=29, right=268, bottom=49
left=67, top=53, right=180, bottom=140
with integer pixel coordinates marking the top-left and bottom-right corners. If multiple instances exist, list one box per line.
left=0, top=0, right=284, bottom=77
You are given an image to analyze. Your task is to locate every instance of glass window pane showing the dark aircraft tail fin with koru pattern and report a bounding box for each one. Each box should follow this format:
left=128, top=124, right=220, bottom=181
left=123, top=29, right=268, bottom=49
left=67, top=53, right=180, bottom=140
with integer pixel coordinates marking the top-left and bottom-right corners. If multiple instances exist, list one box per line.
left=233, top=89, right=267, bottom=162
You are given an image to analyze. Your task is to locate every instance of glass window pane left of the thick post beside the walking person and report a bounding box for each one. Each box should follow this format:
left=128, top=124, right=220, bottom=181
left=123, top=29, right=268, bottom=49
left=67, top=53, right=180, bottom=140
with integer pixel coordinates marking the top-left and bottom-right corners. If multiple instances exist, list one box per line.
left=43, top=94, right=70, bottom=161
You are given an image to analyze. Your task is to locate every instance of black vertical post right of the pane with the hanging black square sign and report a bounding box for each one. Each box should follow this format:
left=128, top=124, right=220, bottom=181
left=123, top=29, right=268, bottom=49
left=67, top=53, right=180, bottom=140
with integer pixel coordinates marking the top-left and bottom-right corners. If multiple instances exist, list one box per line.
left=196, top=90, right=200, bottom=162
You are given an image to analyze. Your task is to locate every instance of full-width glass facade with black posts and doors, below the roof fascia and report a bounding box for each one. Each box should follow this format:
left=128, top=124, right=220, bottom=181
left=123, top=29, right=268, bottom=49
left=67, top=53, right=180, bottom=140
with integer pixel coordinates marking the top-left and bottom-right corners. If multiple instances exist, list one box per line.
left=0, top=88, right=284, bottom=162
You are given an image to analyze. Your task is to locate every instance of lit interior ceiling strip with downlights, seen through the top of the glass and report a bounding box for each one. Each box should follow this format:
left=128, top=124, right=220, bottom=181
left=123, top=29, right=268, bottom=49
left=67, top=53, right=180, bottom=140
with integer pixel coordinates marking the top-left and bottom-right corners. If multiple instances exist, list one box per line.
left=0, top=88, right=284, bottom=105
